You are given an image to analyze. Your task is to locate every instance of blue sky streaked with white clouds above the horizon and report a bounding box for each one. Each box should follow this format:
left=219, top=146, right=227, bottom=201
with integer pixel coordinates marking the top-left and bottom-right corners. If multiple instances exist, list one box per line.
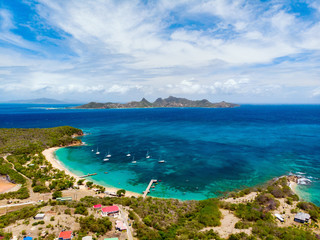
left=0, top=0, right=320, bottom=103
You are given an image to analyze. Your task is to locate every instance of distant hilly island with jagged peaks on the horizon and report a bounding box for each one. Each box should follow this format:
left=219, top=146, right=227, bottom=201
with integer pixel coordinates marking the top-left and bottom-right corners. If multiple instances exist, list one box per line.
left=73, top=96, right=240, bottom=109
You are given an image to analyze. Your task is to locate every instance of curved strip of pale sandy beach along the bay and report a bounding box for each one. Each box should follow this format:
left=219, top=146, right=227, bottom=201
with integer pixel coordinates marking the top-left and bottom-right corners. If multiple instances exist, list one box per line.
left=42, top=145, right=142, bottom=197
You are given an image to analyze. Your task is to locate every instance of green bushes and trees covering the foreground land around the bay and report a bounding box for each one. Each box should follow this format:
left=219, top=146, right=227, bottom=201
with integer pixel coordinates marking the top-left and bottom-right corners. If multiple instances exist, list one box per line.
left=0, top=126, right=320, bottom=240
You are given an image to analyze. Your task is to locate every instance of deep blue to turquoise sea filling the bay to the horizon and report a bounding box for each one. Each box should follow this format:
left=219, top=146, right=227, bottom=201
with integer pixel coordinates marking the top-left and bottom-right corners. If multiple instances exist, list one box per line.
left=0, top=104, right=320, bottom=205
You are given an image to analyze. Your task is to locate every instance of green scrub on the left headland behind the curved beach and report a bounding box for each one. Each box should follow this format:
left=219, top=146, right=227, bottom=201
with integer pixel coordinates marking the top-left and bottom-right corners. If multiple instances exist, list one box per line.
left=0, top=126, right=82, bottom=200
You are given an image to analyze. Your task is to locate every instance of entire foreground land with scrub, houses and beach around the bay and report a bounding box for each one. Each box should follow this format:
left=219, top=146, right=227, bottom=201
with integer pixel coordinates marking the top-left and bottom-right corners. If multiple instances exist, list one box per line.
left=0, top=126, right=320, bottom=240
